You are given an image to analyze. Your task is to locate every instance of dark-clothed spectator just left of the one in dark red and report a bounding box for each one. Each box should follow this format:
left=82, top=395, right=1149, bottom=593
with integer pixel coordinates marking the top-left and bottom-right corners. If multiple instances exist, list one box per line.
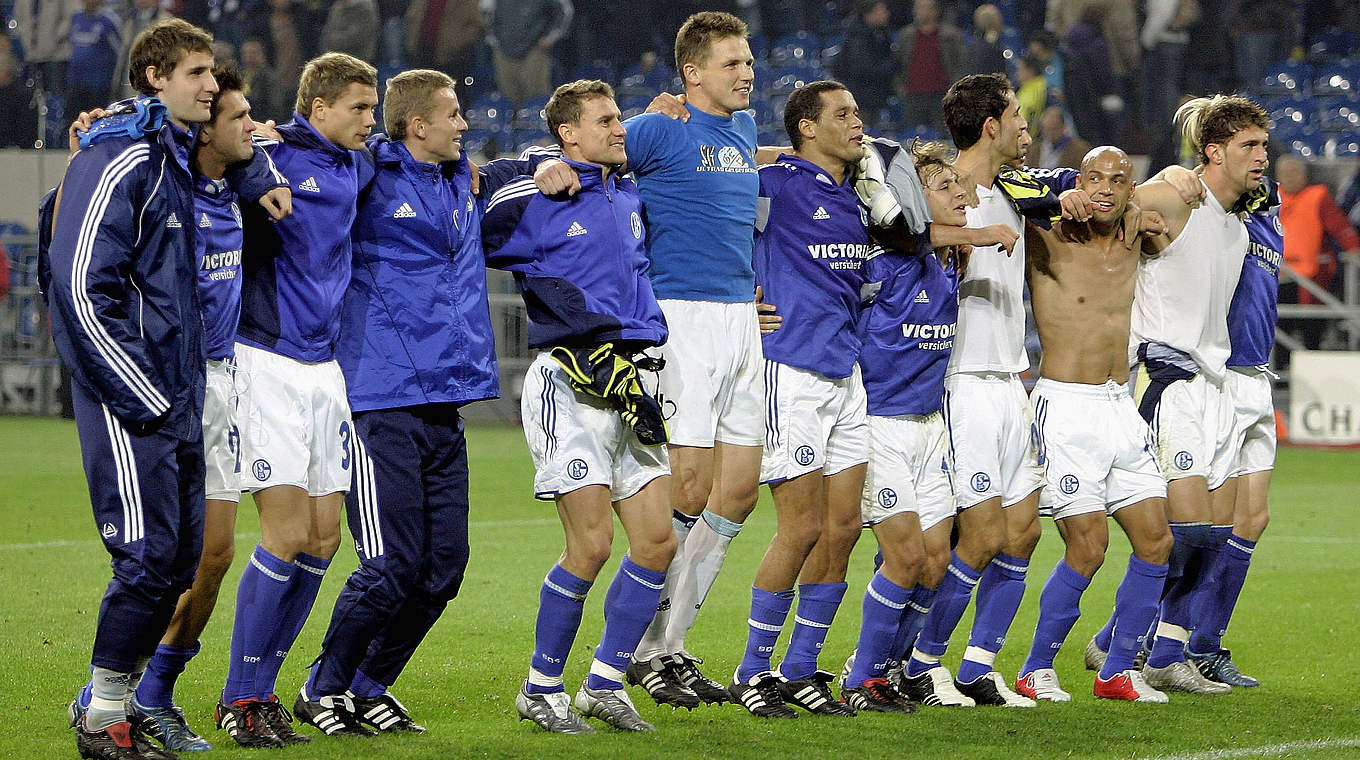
left=834, top=0, right=896, bottom=126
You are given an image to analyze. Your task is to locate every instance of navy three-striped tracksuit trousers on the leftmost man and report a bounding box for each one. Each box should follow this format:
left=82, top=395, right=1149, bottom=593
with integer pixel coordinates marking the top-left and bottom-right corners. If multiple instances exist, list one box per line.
left=71, top=383, right=204, bottom=673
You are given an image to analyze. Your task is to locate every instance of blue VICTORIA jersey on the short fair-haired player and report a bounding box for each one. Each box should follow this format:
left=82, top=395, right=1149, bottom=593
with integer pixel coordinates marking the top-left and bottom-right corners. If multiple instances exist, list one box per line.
left=860, top=232, right=959, bottom=416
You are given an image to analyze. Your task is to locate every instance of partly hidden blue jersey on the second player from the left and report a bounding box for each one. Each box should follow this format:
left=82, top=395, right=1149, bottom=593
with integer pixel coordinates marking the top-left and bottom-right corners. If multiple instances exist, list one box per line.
left=193, top=175, right=243, bottom=359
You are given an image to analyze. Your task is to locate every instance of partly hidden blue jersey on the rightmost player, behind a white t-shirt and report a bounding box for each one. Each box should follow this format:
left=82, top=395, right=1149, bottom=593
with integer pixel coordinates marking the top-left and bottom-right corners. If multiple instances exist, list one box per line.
left=1228, top=209, right=1284, bottom=367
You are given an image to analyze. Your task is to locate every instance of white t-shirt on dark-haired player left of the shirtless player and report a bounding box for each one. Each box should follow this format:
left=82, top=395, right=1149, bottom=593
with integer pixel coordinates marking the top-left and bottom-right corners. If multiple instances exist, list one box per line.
left=947, top=185, right=1028, bottom=374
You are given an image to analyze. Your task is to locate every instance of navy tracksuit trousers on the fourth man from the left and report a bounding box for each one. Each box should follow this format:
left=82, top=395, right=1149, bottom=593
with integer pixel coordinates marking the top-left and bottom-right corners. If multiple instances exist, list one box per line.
left=313, top=404, right=468, bottom=697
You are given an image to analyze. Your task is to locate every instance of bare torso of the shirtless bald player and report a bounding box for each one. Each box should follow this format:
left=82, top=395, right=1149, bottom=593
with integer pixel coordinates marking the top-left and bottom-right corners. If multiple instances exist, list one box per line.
left=1025, top=222, right=1138, bottom=385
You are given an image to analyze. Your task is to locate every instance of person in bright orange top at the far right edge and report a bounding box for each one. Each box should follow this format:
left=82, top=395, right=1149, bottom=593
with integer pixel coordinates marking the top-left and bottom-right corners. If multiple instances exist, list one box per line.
left=1274, top=154, right=1360, bottom=348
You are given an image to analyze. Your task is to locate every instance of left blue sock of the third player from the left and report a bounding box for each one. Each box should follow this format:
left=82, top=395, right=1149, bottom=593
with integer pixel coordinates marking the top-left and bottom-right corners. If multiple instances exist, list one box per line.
left=222, top=545, right=292, bottom=704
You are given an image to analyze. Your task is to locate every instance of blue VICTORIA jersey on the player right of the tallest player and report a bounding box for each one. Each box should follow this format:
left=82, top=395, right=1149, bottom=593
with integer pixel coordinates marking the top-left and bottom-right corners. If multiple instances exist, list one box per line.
left=755, top=155, right=869, bottom=378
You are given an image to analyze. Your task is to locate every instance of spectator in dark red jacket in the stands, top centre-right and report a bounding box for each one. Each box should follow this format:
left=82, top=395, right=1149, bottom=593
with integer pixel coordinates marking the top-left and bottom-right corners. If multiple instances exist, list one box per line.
left=898, top=0, right=963, bottom=129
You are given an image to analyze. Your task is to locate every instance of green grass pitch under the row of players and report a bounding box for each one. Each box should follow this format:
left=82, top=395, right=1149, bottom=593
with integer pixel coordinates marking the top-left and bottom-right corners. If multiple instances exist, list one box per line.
left=0, top=417, right=1360, bottom=760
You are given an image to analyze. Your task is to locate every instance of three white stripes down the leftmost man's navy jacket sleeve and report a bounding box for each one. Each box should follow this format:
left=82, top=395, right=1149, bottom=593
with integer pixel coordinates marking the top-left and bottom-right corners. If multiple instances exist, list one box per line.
left=71, top=143, right=172, bottom=417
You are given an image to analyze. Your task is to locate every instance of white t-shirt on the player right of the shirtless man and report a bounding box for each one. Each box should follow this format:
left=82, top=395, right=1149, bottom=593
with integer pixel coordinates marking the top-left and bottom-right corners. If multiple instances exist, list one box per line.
left=1129, top=186, right=1247, bottom=382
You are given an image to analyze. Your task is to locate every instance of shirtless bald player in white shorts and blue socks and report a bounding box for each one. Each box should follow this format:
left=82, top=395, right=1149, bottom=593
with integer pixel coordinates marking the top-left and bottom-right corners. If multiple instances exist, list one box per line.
left=1016, top=147, right=1171, bottom=702
